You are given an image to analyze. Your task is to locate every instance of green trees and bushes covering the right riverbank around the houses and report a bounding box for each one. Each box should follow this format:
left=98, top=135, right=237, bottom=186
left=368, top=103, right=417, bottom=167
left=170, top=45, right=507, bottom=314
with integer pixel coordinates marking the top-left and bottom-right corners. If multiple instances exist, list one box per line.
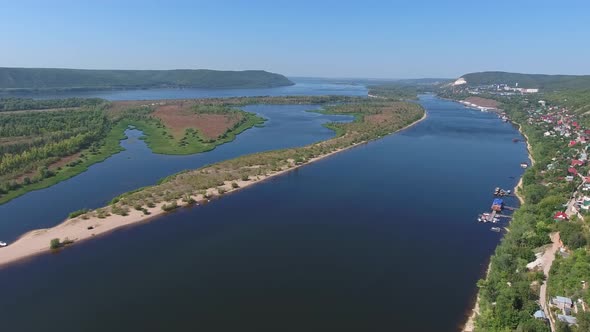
left=476, top=92, right=590, bottom=331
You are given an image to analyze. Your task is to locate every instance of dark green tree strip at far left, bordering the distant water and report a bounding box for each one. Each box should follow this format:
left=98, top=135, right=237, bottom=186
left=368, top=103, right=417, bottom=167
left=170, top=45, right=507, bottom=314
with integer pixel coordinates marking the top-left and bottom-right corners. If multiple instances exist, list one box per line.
left=0, top=97, right=106, bottom=112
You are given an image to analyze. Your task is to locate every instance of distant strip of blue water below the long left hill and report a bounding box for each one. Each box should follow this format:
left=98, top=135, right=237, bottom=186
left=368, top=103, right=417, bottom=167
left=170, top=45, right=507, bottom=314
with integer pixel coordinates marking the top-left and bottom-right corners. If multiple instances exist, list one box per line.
left=1, top=78, right=367, bottom=100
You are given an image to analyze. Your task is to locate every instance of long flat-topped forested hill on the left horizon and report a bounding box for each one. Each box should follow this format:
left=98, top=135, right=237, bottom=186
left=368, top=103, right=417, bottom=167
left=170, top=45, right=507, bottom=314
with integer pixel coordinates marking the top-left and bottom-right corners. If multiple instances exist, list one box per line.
left=0, top=67, right=294, bottom=90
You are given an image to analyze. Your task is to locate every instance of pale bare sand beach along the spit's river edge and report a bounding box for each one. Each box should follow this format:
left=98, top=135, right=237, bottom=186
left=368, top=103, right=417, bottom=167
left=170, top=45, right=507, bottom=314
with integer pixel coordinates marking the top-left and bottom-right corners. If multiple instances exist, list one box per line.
left=0, top=111, right=427, bottom=266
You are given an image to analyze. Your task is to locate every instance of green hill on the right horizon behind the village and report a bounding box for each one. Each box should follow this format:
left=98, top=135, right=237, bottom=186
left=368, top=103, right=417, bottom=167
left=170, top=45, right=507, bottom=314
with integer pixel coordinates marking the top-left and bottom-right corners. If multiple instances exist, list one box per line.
left=462, top=71, right=590, bottom=91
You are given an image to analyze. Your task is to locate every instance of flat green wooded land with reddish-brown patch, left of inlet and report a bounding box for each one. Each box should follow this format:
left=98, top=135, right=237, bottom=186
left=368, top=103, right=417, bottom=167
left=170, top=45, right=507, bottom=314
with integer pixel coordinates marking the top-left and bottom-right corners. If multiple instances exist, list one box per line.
left=0, top=96, right=358, bottom=203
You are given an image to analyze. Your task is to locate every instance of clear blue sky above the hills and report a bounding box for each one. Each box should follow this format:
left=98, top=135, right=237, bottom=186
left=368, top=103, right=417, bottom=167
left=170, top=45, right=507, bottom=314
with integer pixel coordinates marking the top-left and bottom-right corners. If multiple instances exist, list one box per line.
left=0, top=0, right=590, bottom=78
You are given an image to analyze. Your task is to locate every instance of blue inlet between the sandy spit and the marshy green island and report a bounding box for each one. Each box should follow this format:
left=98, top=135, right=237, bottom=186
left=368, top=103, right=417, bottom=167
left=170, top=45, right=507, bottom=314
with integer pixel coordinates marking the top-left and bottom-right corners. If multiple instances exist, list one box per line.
left=0, top=105, right=352, bottom=241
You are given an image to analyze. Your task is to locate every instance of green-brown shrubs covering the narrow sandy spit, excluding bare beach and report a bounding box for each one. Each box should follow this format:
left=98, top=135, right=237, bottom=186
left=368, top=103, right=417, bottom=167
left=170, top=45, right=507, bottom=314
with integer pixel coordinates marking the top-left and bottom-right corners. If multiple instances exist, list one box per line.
left=81, top=99, right=424, bottom=219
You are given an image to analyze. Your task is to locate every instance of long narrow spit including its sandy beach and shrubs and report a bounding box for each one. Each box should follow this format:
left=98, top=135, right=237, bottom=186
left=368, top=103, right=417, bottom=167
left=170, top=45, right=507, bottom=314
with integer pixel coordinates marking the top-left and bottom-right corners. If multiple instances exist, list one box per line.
left=0, top=93, right=426, bottom=265
